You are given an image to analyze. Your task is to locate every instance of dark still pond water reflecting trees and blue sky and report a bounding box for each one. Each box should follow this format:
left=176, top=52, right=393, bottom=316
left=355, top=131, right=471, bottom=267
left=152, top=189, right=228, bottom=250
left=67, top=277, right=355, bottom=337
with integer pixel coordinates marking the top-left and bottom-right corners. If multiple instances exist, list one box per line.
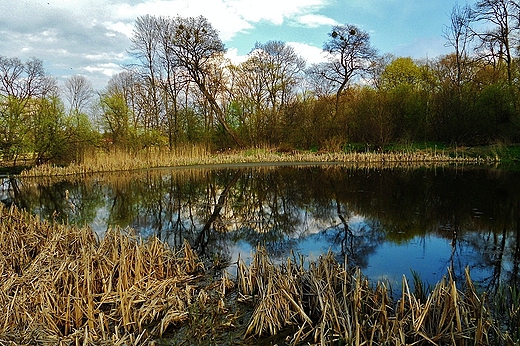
left=4, top=165, right=520, bottom=290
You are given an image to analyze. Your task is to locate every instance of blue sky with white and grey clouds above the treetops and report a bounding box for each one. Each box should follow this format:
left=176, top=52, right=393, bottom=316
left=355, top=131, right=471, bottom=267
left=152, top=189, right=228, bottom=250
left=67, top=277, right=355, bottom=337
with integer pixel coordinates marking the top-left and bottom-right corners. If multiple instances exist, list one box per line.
left=0, top=0, right=471, bottom=90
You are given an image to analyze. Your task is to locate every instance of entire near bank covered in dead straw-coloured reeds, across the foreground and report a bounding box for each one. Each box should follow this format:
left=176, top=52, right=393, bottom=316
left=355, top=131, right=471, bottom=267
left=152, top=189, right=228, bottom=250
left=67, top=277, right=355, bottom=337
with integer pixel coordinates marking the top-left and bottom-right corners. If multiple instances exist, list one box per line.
left=0, top=207, right=518, bottom=345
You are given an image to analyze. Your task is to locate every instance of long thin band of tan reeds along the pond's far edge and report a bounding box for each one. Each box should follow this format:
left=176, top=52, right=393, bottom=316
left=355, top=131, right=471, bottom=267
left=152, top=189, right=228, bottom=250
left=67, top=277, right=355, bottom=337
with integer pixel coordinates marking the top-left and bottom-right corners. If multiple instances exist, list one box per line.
left=21, top=146, right=499, bottom=177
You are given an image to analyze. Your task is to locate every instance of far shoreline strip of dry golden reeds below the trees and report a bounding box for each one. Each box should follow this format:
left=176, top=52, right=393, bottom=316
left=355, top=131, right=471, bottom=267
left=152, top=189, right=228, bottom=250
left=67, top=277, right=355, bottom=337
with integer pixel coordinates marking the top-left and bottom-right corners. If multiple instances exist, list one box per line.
left=20, top=149, right=501, bottom=177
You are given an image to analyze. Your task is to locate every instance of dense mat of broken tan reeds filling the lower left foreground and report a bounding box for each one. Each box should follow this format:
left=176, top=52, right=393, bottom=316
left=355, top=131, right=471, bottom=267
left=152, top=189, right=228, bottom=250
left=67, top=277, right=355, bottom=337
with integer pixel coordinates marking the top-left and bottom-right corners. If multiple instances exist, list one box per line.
left=0, top=207, right=232, bottom=345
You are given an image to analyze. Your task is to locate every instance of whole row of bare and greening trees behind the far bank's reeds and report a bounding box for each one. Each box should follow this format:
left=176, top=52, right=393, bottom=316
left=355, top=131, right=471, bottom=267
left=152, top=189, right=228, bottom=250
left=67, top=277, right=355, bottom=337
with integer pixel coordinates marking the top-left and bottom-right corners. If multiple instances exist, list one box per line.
left=0, top=0, right=520, bottom=162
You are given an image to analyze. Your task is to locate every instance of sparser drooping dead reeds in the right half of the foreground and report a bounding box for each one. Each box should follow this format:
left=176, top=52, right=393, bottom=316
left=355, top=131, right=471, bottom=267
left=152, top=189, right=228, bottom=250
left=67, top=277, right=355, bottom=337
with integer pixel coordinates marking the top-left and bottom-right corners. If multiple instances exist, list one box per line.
left=237, top=249, right=503, bottom=345
